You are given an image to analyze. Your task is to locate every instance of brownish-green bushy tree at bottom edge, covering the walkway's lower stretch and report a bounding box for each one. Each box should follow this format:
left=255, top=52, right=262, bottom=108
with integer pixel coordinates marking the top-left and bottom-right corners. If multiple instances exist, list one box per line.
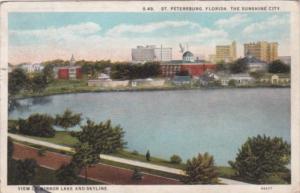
left=183, top=153, right=218, bottom=184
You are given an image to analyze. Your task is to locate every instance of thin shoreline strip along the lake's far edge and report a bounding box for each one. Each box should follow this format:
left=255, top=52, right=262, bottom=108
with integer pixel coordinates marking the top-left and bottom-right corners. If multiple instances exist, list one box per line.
left=15, top=86, right=291, bottom=100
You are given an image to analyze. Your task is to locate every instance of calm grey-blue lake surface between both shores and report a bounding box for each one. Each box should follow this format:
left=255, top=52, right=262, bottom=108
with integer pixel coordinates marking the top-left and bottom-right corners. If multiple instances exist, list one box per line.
left=9, top=88, right=290, bottom=165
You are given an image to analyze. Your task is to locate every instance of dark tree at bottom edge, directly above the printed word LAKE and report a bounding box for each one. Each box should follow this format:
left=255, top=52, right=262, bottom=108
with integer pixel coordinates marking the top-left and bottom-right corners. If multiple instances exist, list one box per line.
left=55, top=162, right=79, bottom=185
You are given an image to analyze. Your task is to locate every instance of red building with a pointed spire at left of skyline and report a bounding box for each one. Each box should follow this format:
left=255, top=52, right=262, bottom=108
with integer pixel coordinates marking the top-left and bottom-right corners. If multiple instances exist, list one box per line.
left=54, top=55, right=82, bottom=80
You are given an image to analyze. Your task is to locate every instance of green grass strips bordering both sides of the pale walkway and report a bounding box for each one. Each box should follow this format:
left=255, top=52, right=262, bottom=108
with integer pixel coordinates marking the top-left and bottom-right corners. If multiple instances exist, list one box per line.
left=9, top=131, right=234, bottom=179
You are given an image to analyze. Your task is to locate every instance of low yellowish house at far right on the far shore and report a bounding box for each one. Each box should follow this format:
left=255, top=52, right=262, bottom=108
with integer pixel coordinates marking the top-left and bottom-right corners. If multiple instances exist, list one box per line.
left=259, top=73, right=291, bottom=86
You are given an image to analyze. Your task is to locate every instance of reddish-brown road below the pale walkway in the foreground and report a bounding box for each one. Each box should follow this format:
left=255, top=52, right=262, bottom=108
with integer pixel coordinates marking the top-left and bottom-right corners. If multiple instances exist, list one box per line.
left=13, top=143, right=182, bottom=185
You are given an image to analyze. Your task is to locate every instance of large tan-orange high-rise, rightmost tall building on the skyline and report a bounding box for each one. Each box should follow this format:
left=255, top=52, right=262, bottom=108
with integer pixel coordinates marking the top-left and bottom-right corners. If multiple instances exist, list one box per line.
left=244, top=41, right=278, bottom=63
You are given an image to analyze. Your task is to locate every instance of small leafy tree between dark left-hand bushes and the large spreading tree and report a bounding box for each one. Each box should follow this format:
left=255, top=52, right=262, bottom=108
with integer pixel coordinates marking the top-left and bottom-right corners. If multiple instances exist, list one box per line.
left=55, top=109, right=81, bottom=130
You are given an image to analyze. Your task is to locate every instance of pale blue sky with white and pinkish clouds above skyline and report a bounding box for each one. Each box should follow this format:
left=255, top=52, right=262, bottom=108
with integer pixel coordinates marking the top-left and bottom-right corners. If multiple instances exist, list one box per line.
left=8, top=12, right=290, bottom=64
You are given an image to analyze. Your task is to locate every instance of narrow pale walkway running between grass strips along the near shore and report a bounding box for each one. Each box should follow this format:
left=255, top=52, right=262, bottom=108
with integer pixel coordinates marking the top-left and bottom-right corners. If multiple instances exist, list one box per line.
left=8, top=133, right=249, bottom=185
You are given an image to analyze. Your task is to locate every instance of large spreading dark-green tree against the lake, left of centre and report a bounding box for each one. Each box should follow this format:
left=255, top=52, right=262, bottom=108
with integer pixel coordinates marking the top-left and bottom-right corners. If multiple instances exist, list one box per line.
left=73, top=120, right=126, bottom=154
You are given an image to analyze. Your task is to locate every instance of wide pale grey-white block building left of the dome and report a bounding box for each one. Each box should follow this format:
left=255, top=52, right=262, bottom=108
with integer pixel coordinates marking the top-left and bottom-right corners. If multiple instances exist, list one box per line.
left=131, top=45, right=172, bottom=63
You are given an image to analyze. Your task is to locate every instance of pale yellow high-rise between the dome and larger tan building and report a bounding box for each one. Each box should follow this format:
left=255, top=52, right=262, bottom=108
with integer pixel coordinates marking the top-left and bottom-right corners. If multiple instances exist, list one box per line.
left=214, top=41, right=236, bottom=62
